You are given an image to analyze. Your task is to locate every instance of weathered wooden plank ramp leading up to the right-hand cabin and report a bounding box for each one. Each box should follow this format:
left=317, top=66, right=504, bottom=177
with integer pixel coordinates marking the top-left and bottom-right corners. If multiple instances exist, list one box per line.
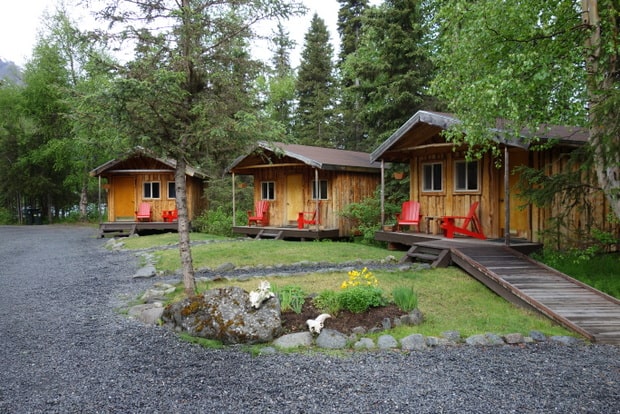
left=451, top=244, right=620, bottom=345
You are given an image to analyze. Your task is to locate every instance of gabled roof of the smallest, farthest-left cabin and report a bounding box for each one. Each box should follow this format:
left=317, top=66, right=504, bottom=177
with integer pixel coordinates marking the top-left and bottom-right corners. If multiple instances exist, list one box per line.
left=90, top=147, right=207, bottom=180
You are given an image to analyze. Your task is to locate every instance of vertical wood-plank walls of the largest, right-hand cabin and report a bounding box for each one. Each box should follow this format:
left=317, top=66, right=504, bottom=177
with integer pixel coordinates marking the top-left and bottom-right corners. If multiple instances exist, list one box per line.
left=409, top=147, right=620, bottom=248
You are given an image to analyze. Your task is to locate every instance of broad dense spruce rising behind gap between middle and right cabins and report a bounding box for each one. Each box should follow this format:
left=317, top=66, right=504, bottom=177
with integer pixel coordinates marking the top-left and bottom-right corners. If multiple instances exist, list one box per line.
left=343, top=0, right=434, bottom=150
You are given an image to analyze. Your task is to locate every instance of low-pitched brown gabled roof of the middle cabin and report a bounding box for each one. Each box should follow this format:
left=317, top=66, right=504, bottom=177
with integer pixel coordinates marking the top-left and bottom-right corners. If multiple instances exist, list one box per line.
left=228, top=141, right=381, bottom=174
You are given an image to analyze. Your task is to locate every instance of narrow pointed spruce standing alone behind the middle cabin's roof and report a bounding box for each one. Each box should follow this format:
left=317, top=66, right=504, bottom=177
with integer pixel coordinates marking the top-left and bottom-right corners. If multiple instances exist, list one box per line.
left=294, top=14, right=335, bottom=147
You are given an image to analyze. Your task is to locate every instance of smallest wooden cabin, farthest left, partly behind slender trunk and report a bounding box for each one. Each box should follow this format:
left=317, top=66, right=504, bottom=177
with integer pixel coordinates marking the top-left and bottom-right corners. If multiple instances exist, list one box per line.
left=90, top=149, right=207, bottom=236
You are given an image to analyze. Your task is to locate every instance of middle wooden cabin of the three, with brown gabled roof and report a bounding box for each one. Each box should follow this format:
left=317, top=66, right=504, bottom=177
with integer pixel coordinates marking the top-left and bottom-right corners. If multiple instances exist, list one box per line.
left=229, top=142, right=381, bottom=238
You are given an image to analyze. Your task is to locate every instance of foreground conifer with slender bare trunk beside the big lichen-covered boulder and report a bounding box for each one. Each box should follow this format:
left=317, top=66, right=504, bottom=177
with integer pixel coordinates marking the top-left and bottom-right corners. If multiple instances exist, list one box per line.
left=94, top=0, right=302, bottom=295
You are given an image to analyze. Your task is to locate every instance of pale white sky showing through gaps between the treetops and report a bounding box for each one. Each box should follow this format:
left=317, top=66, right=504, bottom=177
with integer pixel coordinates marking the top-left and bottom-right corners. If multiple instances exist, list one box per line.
left=0, top=0, right=380, bottom=67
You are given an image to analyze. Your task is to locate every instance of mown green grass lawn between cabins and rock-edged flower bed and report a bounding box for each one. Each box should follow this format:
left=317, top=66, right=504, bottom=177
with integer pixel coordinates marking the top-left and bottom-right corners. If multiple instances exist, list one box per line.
left=125, top=234, right=572, bottom=338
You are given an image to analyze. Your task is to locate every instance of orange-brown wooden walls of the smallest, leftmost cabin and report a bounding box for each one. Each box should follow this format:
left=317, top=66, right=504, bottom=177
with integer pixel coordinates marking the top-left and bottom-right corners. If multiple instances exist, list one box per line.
left=106, top=172, right=205, bottom=222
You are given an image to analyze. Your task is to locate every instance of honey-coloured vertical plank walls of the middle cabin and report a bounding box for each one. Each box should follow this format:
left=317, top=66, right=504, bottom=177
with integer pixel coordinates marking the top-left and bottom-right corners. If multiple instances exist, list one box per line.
left=252, top=165, right=380, bottom=237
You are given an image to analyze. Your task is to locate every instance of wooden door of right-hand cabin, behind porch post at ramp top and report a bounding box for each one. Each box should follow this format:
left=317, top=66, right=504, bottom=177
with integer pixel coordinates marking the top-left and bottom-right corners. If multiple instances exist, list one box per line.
left=499, top=150, right=532, bottom=239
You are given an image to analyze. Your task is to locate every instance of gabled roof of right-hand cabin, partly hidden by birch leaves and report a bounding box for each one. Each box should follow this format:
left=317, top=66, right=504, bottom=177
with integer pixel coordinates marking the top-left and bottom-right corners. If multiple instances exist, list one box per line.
left=370, top=111, right=588, bottom=162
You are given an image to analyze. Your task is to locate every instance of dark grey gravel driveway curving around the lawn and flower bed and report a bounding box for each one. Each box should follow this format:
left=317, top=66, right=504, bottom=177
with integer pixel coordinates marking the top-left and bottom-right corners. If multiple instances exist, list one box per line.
left=0, top=226, right=620, bottom=413
